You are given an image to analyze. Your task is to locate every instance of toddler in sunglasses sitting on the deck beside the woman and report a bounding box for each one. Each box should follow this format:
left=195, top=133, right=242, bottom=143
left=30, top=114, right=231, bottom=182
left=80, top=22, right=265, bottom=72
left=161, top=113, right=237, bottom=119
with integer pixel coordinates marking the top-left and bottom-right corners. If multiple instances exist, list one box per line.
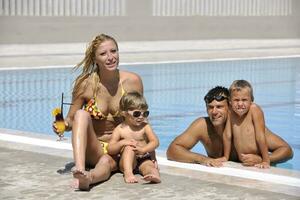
left=108, top=92, right=161, bottom=183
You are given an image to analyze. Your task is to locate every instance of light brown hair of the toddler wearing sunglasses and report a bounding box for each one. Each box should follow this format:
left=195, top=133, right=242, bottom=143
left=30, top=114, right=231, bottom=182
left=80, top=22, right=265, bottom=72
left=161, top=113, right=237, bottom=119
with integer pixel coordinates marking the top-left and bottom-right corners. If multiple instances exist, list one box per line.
left=120, top=92, right=148, bottom=111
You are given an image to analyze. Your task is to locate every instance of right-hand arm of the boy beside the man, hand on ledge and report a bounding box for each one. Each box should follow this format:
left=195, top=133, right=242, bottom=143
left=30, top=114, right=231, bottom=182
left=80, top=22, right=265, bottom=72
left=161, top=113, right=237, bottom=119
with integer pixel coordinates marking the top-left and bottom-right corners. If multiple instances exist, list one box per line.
left=251, top=104, right=270, bottom=168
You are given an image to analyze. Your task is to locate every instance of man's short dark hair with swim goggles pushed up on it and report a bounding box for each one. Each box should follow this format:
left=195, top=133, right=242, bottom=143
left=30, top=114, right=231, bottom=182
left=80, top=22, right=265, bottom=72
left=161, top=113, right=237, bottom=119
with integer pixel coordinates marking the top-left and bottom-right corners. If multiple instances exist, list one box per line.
left=204, top=86, right=229, bottom=104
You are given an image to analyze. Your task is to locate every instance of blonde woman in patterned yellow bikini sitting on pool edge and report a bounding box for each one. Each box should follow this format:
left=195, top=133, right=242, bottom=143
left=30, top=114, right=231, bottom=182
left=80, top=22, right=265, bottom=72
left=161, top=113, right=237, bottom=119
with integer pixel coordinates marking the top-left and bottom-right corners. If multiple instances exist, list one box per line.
left=53, top=34, right=143, bottom=190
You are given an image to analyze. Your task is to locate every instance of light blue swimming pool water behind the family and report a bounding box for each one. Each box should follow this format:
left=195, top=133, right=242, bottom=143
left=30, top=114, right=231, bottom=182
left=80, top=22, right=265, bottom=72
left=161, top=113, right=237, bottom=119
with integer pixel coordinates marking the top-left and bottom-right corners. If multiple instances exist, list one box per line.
left=0, top=58, right=300, bottom=170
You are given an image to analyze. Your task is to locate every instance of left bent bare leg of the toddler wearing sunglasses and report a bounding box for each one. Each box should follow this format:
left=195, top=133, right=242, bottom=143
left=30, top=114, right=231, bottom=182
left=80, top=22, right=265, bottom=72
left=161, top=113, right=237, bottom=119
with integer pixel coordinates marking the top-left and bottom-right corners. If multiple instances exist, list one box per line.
left=120, top=146, right=138, bottom=183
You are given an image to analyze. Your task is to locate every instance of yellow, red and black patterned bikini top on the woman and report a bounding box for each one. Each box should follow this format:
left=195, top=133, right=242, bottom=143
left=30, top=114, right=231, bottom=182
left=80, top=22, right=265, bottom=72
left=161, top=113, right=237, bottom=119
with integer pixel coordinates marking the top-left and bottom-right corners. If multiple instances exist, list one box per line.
left=83, top=82, right=126, bottom=120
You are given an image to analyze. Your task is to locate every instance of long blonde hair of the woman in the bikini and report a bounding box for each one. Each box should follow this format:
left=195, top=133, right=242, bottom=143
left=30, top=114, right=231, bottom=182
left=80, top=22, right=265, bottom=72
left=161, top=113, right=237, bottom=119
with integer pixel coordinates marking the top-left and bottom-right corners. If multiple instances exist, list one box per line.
left=73, top=34, right=119, bottom=97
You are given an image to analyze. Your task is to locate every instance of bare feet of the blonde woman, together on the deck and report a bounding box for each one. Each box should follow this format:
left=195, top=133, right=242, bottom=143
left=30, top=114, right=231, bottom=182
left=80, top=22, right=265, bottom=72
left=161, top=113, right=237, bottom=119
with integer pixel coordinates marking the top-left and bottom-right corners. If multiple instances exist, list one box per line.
left=72, top=168, right=92, bottom=190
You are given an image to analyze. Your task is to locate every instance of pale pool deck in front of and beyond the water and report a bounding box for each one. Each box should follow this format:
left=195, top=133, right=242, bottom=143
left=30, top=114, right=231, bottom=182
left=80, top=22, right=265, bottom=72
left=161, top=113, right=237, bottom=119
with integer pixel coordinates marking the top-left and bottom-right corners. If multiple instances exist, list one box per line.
left=0, top=39, right=300, bottom=199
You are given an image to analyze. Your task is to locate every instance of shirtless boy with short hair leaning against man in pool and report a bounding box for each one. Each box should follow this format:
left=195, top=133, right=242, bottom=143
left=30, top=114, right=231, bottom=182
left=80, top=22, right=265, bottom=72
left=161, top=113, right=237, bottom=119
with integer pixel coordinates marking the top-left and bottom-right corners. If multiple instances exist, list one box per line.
left=223, top=80, right=270, bottom=168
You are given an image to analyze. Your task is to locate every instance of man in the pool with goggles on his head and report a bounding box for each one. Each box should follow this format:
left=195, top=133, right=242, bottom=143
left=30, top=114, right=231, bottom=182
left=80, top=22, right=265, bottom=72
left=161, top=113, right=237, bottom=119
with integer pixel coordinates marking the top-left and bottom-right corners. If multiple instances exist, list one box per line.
left=167, top=86, right=293, bottom=167
